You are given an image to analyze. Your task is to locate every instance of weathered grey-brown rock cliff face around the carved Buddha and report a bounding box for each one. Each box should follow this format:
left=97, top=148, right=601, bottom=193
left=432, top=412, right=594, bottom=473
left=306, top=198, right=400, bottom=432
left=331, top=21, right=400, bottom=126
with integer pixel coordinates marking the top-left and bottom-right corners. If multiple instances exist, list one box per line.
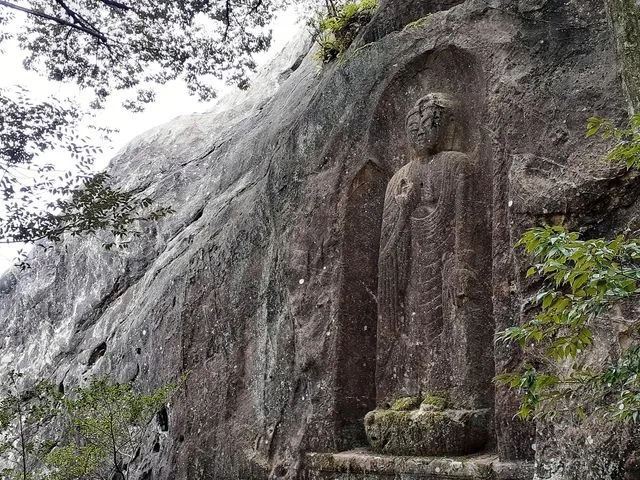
left=0, top=0, right=638, bottom=480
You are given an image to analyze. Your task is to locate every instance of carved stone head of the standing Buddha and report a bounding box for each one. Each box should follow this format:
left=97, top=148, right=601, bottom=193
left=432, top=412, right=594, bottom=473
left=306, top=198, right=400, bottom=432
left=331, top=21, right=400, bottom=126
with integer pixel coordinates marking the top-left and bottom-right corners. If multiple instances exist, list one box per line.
left=406, top=93, right=455, bottom=158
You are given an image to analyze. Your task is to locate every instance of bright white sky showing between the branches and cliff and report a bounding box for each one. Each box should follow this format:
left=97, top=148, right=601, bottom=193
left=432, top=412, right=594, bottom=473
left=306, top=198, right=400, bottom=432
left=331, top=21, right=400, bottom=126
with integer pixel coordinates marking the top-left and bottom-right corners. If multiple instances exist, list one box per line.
left=0, top=8, right=301, bottom=274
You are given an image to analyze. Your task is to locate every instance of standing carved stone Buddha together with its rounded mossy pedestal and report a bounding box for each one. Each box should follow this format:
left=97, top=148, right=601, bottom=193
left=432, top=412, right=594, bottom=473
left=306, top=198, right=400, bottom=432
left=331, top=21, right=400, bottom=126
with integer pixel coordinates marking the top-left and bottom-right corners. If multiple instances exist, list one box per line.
left=364, top=93, right=493, bottom=455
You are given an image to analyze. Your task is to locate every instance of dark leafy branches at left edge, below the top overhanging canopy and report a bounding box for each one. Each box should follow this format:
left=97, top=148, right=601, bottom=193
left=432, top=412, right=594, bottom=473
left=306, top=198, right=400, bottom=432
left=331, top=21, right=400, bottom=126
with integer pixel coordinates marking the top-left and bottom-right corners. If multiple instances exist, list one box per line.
left=0, top=89, right=172, bottom=262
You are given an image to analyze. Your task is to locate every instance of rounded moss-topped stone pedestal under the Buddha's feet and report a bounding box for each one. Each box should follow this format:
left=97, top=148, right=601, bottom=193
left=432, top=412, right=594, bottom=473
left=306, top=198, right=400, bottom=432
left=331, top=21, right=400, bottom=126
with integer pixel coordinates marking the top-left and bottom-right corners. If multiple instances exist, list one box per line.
left=364, top=409, right=490, bottom=456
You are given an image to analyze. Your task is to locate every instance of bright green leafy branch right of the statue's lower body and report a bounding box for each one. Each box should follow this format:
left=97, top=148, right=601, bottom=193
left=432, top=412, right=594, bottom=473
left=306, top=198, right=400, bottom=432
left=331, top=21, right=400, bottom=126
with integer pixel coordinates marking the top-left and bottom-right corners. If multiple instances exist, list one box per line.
left=498, top=226, right=640, bottom=359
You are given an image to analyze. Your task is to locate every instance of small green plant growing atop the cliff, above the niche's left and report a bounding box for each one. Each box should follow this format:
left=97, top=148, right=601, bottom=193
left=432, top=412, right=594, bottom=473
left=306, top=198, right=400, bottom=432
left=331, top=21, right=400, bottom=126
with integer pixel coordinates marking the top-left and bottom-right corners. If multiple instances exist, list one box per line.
left=311, top=0, right=378, bottom=64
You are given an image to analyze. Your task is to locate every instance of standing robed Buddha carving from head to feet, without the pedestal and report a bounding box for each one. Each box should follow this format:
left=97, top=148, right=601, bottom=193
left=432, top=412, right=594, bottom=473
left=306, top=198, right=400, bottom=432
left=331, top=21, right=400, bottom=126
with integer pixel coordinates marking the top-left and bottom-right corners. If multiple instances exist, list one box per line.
left=376, top=93, right=490, bottom=408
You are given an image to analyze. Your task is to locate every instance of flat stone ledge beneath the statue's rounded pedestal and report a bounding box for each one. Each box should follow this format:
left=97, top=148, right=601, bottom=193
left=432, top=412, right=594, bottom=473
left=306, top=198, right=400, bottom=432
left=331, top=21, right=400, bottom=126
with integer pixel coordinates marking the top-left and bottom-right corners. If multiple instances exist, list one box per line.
left=302, top=450, right=534, bottom=480
